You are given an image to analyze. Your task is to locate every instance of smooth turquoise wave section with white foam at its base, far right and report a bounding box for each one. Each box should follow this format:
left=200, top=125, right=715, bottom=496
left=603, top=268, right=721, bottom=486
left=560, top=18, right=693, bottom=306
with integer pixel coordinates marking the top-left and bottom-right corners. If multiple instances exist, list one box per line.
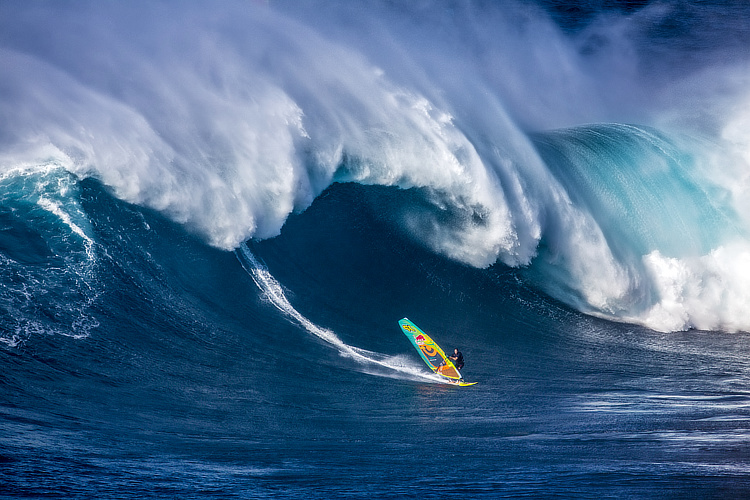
left=530, top=125, right=750, bottom=331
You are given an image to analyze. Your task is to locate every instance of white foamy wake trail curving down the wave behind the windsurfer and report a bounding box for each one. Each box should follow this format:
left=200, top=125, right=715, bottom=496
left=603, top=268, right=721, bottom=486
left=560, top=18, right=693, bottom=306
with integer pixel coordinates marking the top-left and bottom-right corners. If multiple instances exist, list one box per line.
left=235, top=244, right=443, bottom=383
